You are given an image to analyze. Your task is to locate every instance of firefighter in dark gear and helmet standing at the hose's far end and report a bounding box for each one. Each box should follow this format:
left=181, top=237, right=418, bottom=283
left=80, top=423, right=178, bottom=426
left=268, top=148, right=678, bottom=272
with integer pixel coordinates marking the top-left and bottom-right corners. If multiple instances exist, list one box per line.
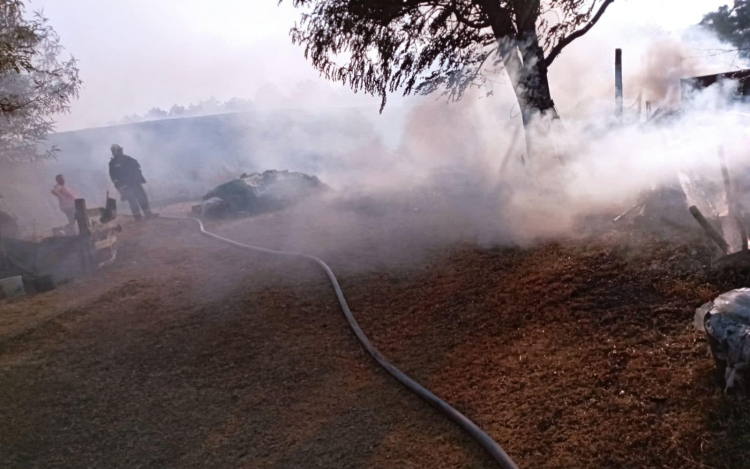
left=109, top=143, right=156, bottom=221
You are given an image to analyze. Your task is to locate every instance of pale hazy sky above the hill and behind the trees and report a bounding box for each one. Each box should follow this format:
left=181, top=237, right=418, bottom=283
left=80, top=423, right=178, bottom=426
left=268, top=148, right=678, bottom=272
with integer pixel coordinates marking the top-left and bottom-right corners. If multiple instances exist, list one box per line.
left=31, top=0, right=727, bottom=130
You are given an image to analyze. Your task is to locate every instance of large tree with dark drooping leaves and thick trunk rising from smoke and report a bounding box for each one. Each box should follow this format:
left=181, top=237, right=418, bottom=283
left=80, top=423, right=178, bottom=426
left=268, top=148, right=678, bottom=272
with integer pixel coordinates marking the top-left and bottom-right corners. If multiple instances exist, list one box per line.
left=282, top=0, right=614, bottom=126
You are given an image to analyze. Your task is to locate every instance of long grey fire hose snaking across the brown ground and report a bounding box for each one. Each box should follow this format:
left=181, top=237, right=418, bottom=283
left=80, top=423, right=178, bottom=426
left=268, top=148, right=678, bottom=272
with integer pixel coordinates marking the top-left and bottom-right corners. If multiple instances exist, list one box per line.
left=173, top=217, right=518, bottom=469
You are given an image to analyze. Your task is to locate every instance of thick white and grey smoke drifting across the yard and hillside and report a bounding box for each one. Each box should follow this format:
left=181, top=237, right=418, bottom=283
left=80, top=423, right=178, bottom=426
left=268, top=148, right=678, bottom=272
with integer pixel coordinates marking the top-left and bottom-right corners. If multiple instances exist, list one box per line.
left=0, top=15, right=750, bottom=265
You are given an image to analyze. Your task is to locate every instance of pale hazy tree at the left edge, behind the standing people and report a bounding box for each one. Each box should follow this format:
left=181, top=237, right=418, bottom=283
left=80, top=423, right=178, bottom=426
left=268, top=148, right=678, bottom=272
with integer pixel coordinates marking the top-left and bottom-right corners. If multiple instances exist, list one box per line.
left=0, top=0, right=82, bottom=162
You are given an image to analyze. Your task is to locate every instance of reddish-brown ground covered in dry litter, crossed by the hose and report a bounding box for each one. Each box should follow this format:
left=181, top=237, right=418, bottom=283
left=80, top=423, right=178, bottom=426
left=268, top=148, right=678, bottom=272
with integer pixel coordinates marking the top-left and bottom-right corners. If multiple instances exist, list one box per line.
left=0, top=215, right=750, bottom=469
